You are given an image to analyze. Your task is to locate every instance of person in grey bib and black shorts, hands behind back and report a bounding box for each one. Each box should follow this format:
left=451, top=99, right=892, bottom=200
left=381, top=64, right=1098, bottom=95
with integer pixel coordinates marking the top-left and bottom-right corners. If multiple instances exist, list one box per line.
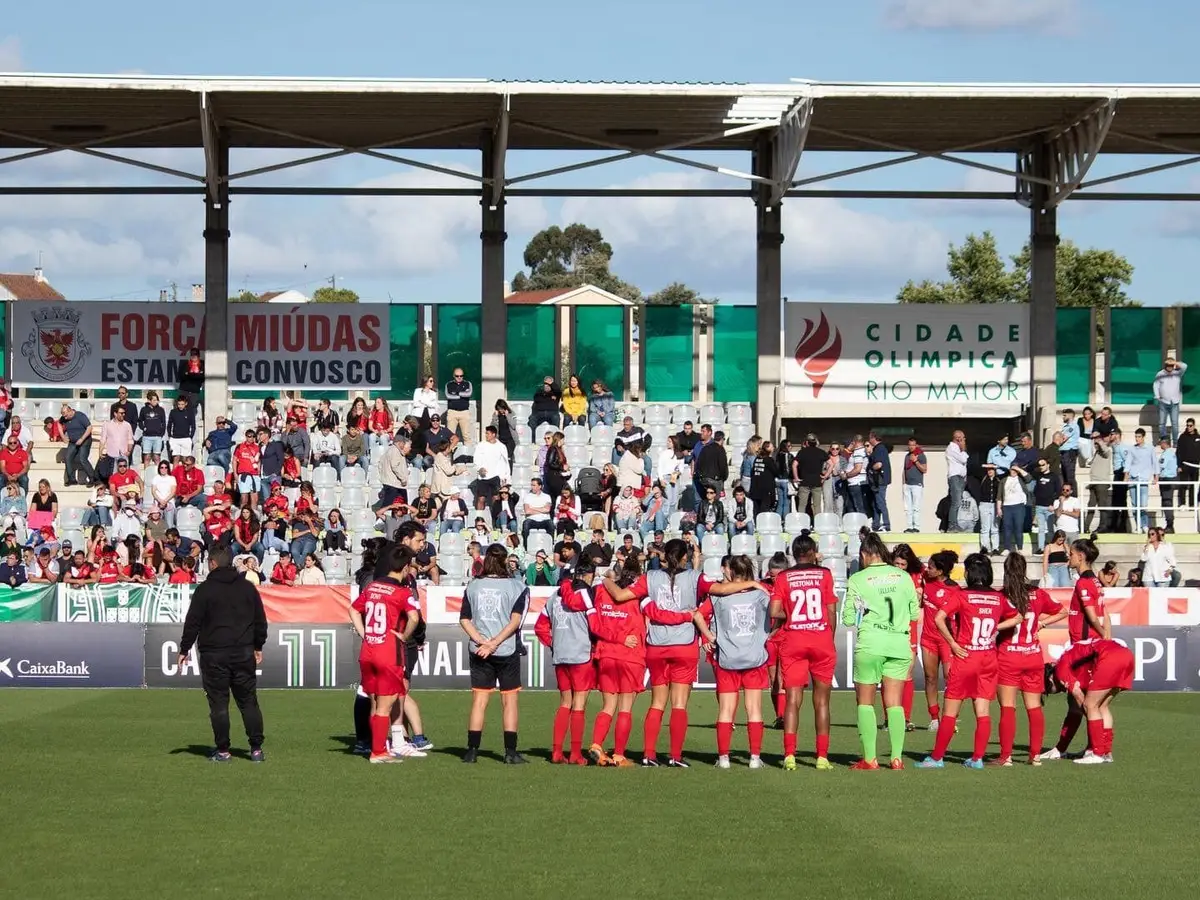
left=458, top=544, right=529, bottom=766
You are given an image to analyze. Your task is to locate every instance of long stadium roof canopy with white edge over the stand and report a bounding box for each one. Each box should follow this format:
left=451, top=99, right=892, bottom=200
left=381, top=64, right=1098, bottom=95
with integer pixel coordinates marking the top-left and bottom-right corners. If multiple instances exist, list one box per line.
left=7, top=73, right=1200, bottom=199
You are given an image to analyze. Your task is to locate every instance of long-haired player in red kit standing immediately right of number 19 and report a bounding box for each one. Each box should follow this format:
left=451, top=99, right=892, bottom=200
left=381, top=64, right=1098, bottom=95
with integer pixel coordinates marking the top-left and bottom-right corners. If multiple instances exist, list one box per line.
left=991, top=553, right=1067, bottom=767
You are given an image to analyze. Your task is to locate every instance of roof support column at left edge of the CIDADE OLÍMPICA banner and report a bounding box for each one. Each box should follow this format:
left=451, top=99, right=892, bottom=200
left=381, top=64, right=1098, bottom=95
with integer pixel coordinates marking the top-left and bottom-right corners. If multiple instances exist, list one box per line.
left=752, top=140, right=784, bottom=440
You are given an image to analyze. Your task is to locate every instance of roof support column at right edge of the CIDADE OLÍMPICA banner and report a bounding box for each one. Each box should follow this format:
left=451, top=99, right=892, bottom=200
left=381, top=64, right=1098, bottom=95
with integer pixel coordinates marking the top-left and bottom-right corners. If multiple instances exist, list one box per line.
left=1028, top=143, right=1056, bottom=446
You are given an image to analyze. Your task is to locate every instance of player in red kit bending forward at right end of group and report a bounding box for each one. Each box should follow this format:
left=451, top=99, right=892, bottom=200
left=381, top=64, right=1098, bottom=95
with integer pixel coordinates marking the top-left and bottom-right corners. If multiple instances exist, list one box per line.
left=1055, top=638, right=1134, bottom=766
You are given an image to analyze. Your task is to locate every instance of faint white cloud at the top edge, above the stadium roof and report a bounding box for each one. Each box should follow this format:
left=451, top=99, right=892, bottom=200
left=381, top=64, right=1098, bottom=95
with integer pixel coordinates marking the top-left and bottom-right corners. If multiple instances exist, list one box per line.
left=883, top=0, right=1080, bottom=34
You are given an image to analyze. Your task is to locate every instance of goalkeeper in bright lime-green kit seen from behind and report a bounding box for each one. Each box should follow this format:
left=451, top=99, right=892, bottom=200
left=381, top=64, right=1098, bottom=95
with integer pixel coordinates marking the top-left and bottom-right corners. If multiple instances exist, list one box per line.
left=841, top=533, right=920, bottom=770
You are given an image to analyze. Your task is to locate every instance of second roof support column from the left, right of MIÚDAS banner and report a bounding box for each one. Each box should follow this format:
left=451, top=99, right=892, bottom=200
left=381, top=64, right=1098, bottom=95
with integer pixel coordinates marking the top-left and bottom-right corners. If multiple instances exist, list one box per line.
left=477, top=133, right=508, bottom=433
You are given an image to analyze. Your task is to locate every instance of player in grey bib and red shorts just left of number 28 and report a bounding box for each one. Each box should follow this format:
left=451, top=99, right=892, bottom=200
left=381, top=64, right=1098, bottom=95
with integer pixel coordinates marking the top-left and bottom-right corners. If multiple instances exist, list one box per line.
left=694, top=556, right=770, bottom=769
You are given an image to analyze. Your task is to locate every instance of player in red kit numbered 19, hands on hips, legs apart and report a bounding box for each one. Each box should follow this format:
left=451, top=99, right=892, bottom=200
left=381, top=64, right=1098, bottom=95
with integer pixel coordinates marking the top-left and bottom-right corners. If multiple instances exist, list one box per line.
left=917, top=553, right=1020, bottom=769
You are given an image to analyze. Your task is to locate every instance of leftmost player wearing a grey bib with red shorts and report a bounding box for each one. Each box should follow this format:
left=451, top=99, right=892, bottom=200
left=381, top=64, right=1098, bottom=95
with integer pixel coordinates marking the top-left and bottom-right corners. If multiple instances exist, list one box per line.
left=534, top=562, right=596, bottom=766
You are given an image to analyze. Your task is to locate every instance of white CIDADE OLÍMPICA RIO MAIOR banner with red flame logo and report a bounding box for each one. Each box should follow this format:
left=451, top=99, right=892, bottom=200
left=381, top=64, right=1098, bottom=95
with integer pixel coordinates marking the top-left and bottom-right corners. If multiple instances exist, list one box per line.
left=784, top=302, right=1032, bottom=415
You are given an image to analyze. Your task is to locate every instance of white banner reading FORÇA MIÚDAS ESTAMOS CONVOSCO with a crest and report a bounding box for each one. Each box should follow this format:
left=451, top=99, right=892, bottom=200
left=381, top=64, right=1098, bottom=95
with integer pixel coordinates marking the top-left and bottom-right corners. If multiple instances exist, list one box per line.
left=11, top=301, right=391, bottom=390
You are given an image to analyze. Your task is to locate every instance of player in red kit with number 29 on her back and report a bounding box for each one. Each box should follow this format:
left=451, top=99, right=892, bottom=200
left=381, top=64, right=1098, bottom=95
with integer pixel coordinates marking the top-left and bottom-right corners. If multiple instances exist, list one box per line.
left=350, top=546, right=420, bottom=763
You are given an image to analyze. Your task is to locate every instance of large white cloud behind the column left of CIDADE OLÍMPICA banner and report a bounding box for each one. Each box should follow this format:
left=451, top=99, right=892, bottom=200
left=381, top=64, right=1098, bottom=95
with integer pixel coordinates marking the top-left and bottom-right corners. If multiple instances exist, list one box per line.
left=562, top=173, right=947, bottom=299
